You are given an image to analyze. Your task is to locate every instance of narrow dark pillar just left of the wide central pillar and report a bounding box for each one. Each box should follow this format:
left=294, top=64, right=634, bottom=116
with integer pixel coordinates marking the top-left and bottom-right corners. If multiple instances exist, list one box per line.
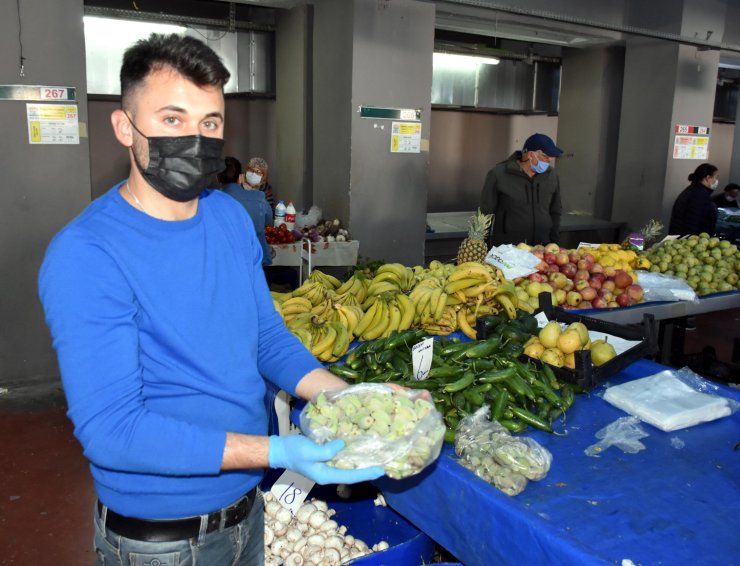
left=273, top=5, right=313, bottom=210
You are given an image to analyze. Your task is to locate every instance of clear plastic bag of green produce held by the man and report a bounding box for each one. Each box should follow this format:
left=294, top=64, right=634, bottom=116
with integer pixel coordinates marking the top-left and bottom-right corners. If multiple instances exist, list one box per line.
left=300, top=383, right=445, bottom=479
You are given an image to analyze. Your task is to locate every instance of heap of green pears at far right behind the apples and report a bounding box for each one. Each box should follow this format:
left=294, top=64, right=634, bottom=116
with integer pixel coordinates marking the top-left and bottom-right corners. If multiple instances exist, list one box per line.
left=646, top=233, right=740, bottom=295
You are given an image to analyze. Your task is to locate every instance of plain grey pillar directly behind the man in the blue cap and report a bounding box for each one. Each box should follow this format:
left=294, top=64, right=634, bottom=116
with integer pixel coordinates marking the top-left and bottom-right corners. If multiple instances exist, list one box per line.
left=557, top=47, right=624, bottom=222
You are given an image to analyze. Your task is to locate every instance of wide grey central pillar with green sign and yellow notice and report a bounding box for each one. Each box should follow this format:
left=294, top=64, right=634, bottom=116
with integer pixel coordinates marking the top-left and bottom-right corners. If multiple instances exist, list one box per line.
left=313, top=0, right=435, bottom=265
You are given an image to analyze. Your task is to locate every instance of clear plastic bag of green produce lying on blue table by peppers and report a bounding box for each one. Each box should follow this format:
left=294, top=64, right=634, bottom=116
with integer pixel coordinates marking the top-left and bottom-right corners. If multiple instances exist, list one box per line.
left=455, top=405, right=552, bottom=495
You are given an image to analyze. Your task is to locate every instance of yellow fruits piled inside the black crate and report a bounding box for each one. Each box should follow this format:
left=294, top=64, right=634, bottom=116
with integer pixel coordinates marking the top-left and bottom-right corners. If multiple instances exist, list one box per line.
left=524, top=320, right=617, bottom=369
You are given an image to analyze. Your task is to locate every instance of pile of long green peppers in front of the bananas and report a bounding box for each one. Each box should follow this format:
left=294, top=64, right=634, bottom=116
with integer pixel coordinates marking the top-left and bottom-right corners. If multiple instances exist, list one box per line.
left=329, top=312, right=575, bottom=441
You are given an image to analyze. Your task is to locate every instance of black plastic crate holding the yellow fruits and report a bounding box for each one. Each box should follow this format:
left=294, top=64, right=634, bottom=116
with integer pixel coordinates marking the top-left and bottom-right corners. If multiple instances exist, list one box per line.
left=477, top=293, right=658, bottom=389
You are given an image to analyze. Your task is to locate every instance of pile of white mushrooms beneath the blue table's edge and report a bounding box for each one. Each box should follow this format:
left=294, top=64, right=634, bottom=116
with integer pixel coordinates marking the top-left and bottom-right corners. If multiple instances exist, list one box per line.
left=264, top=492, right=389, bottom=566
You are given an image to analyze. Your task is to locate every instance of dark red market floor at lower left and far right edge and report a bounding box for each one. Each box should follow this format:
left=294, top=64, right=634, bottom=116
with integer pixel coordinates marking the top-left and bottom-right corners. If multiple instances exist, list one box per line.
left=0, top=309, right=740, bottom=566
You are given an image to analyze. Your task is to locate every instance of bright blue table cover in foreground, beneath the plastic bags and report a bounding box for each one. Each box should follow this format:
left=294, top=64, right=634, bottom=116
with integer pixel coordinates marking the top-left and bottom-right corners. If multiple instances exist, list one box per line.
left=376, top=360, right=740, bottom=566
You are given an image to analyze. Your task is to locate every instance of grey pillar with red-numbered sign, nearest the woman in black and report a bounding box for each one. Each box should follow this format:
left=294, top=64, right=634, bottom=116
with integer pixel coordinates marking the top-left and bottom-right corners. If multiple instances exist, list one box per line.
left=612, top=0, right=725, bottom=233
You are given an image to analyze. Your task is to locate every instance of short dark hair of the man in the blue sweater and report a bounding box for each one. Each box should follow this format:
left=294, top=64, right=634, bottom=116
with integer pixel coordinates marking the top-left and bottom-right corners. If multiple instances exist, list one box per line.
left=121, top=33, right=231, bottom=112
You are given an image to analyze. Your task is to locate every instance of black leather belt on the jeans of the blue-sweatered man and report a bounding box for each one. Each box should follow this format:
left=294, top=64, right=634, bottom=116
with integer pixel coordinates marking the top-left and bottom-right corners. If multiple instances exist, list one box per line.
left=98, top=487, right=257, bottom=542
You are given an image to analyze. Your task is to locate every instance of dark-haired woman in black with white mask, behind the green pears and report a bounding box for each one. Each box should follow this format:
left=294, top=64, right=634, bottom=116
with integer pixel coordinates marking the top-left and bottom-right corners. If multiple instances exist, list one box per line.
left=668, top=163, right=719, bottom=236
